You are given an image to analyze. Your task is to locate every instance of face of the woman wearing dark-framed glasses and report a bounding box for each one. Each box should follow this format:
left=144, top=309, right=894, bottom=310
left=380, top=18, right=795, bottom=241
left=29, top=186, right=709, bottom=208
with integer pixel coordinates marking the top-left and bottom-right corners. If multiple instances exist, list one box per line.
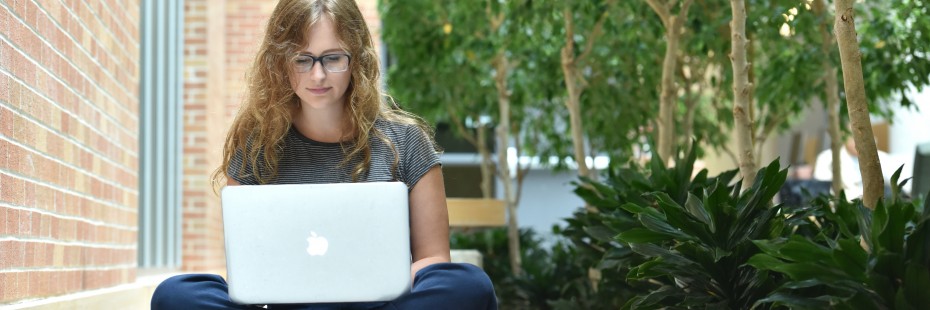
left=290, top=16, right=352, bottom=110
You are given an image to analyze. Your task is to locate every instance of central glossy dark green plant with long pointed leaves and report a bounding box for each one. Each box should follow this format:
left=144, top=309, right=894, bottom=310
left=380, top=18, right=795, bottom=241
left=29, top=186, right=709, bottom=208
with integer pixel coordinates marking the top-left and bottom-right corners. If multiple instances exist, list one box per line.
left=617, top=161, right=787, bottom=309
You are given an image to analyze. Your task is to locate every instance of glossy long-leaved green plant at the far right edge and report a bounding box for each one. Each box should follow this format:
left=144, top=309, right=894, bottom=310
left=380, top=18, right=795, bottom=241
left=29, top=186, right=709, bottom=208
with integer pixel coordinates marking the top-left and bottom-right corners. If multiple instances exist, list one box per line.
left=749, top=169, right=930, bottom=309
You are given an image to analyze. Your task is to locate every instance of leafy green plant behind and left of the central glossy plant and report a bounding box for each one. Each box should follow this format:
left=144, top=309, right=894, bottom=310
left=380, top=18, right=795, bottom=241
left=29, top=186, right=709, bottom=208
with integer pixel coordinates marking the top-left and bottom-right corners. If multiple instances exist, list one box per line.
left=556, top=150, right=735, bottom=308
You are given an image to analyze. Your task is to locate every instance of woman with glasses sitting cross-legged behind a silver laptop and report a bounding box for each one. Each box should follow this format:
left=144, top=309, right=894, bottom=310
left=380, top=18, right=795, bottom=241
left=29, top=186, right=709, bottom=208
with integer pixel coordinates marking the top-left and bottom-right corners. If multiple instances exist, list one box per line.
left=152, top=0, right=497, bottom=309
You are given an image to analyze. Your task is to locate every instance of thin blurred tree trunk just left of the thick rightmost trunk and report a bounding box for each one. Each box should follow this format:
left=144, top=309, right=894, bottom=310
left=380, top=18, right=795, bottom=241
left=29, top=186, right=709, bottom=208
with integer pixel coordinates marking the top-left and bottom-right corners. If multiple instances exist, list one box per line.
left=813, top=0, right=843, bottom=198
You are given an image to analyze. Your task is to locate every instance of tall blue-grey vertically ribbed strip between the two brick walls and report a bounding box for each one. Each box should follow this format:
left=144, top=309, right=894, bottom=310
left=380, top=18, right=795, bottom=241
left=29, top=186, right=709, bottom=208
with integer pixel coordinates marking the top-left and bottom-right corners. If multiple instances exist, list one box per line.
left=138, top=0, right=184, bottom=268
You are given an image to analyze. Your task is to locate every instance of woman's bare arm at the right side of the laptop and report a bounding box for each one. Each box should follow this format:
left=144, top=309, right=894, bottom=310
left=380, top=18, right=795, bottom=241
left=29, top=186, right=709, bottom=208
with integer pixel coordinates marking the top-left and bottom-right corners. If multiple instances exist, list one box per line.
left=410, top=165, right=450, bottom=277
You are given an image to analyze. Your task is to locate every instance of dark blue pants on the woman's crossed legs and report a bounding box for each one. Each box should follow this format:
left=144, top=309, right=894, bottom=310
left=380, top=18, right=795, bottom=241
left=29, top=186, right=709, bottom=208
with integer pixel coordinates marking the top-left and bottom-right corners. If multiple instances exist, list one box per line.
left=152, top=263, right=497, bottom=310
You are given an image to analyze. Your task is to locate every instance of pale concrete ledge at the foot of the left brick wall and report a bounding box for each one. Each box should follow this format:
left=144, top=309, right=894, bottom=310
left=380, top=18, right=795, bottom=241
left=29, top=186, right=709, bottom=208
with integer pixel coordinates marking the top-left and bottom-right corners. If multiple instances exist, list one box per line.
left=0, top=273, right=178, bottom=310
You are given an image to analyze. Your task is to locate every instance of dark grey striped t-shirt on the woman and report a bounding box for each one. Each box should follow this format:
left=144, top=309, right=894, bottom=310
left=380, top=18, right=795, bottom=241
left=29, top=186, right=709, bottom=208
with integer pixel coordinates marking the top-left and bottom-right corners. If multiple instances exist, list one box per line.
left=229, top=119, right=440, bottom=190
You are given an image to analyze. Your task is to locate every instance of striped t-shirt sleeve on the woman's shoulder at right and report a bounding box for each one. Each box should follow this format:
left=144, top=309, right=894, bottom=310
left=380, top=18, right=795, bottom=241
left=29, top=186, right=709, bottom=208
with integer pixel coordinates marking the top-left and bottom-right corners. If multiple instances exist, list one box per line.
left=399, top=125, right=441, bottom=189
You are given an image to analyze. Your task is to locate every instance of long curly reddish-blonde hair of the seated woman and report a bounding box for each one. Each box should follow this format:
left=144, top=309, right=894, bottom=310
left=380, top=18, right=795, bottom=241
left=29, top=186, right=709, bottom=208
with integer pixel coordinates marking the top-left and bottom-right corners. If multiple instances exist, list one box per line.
left=212, top=0, right=435, bottom=189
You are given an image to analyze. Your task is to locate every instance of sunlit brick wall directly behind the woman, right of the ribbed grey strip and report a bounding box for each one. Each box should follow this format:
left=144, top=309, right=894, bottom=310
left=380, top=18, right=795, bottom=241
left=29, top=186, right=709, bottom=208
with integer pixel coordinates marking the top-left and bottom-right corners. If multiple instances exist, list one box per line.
left=183, top=0, right=381, bottom=272
